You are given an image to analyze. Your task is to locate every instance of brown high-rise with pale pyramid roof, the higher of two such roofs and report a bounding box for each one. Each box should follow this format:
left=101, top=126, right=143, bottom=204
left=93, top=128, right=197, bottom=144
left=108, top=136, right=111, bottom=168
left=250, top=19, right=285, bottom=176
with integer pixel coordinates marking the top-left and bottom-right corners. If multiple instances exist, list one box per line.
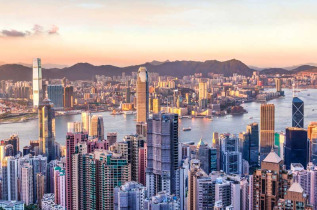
left=252, top=151, right=292, bottom=210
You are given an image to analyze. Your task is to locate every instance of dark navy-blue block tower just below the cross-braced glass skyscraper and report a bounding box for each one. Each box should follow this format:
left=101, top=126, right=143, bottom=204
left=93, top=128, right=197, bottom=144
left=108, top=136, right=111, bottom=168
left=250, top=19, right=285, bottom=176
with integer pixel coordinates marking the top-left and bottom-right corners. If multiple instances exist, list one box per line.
left=284, top=127, right=309, bottom=169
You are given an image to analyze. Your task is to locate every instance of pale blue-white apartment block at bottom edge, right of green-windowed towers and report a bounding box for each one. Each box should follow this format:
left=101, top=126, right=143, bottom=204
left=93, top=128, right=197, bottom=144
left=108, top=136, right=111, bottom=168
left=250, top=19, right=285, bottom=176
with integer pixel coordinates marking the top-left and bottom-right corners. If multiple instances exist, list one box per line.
left=114, top=181, right=146, bottom=210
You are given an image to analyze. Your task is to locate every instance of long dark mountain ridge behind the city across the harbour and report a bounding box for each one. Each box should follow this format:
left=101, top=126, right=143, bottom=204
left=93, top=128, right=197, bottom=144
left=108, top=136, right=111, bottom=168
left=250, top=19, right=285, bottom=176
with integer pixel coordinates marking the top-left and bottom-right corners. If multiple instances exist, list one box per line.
left=0, top=59, right=253, bottom=81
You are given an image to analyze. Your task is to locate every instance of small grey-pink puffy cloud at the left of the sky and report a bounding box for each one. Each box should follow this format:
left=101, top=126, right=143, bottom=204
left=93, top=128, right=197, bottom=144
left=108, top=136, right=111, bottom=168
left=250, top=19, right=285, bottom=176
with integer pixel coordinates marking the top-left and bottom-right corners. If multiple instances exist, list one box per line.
left=0, top=24, right=59, bottom=38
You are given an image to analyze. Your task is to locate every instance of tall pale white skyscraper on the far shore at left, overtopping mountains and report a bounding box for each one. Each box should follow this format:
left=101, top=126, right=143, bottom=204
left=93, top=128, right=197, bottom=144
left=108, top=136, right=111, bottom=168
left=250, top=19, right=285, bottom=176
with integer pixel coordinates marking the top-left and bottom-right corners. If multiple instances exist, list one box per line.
left=33, top=58, right=43, bottom=108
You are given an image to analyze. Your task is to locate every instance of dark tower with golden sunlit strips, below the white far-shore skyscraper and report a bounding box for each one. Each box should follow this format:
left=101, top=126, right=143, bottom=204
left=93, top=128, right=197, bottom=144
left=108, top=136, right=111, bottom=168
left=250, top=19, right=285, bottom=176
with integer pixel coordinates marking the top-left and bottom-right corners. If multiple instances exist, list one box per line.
left=38, top=99, right=55, bottom=161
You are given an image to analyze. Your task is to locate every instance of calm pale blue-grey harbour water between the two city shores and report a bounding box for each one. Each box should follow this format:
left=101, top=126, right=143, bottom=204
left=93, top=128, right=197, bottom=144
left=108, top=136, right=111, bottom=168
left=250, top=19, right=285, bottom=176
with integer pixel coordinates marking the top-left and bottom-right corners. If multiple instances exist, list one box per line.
left=0, top=89, right=317, bottom=150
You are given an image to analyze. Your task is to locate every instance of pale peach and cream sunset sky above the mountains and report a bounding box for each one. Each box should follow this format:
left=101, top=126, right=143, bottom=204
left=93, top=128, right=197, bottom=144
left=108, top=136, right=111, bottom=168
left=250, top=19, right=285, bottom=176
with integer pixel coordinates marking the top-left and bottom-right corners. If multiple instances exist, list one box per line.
left=0, top=0, right=317, bottom=67
